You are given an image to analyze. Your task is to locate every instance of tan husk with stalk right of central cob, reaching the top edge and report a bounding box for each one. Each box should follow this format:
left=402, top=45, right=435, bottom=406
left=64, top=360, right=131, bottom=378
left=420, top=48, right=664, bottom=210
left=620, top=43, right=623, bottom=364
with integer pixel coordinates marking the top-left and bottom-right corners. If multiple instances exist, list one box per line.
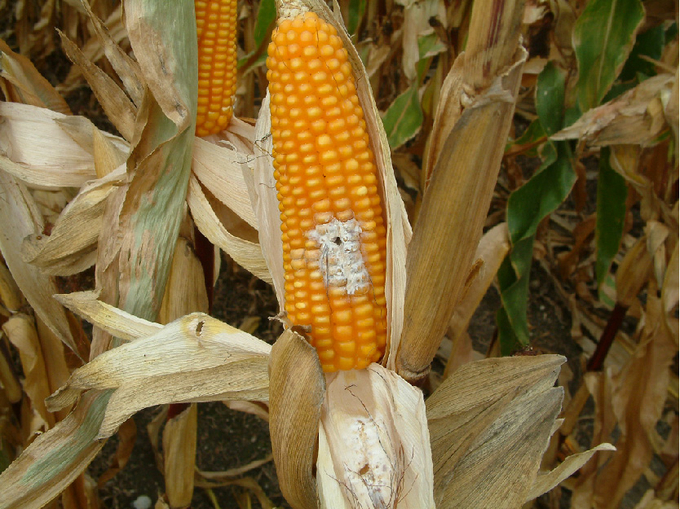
left=396, top=0, right=527, bottom=381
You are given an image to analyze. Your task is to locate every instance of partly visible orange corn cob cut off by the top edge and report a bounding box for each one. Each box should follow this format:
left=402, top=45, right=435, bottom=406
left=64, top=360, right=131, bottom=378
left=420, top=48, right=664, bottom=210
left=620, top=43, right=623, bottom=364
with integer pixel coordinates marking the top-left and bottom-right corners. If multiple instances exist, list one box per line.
left=194, top=0, right=236, bottom=136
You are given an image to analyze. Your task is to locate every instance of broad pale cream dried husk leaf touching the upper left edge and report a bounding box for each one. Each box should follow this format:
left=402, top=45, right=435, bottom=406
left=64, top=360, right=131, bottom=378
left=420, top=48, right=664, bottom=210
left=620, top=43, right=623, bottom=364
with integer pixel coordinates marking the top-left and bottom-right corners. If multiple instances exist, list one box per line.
left=0, top=102, right=97, bottom=189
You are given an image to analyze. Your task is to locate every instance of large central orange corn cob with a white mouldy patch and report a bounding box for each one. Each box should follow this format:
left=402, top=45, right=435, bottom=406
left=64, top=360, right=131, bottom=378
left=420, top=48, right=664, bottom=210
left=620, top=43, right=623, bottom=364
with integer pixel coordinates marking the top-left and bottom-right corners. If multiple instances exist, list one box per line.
left=267, top=12, right=387, bottom=372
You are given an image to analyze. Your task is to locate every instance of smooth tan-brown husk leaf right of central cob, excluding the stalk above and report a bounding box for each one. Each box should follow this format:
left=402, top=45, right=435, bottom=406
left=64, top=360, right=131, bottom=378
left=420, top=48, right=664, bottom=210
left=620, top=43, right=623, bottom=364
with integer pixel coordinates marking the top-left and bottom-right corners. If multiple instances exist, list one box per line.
left=397, top=46, right=526, bottom=381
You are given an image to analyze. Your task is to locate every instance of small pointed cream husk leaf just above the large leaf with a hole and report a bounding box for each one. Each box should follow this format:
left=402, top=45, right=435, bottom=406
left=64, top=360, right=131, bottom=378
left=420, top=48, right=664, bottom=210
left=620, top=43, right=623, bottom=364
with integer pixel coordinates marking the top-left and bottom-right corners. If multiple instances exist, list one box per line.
left=54, top=291, right=163, bottom=341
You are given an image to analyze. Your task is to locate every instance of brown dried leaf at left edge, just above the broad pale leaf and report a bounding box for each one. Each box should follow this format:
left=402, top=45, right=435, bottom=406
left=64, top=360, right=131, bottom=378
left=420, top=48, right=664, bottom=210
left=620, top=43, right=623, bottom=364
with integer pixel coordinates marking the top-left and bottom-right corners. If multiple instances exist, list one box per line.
left=0, top=40, right=71, bottom=115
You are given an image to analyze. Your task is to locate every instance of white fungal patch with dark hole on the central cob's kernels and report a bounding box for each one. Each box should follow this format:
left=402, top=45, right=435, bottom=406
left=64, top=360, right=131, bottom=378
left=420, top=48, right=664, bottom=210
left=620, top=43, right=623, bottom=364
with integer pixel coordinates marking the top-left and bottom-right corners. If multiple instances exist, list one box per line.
left=307, top=218, right=370, bottom=295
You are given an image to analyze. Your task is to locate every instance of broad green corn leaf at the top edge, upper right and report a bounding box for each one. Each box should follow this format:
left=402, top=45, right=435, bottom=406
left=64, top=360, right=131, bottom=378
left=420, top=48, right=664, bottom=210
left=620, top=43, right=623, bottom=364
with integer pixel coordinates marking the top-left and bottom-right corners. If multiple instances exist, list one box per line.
left=573, top=0, right=645, bottom=112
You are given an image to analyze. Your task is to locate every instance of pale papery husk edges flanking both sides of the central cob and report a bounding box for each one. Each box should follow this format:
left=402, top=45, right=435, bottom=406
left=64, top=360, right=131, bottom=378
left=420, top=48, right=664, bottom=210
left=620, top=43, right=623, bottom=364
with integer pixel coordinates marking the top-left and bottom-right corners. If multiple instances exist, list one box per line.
left=251, top=0, right=411, bottom=367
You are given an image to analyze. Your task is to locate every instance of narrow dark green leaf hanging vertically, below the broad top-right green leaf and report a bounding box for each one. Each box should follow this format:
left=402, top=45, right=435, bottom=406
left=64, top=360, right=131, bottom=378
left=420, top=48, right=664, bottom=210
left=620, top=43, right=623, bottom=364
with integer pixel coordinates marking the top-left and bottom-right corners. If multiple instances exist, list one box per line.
left=595, top=147, right=628, bottom=294
